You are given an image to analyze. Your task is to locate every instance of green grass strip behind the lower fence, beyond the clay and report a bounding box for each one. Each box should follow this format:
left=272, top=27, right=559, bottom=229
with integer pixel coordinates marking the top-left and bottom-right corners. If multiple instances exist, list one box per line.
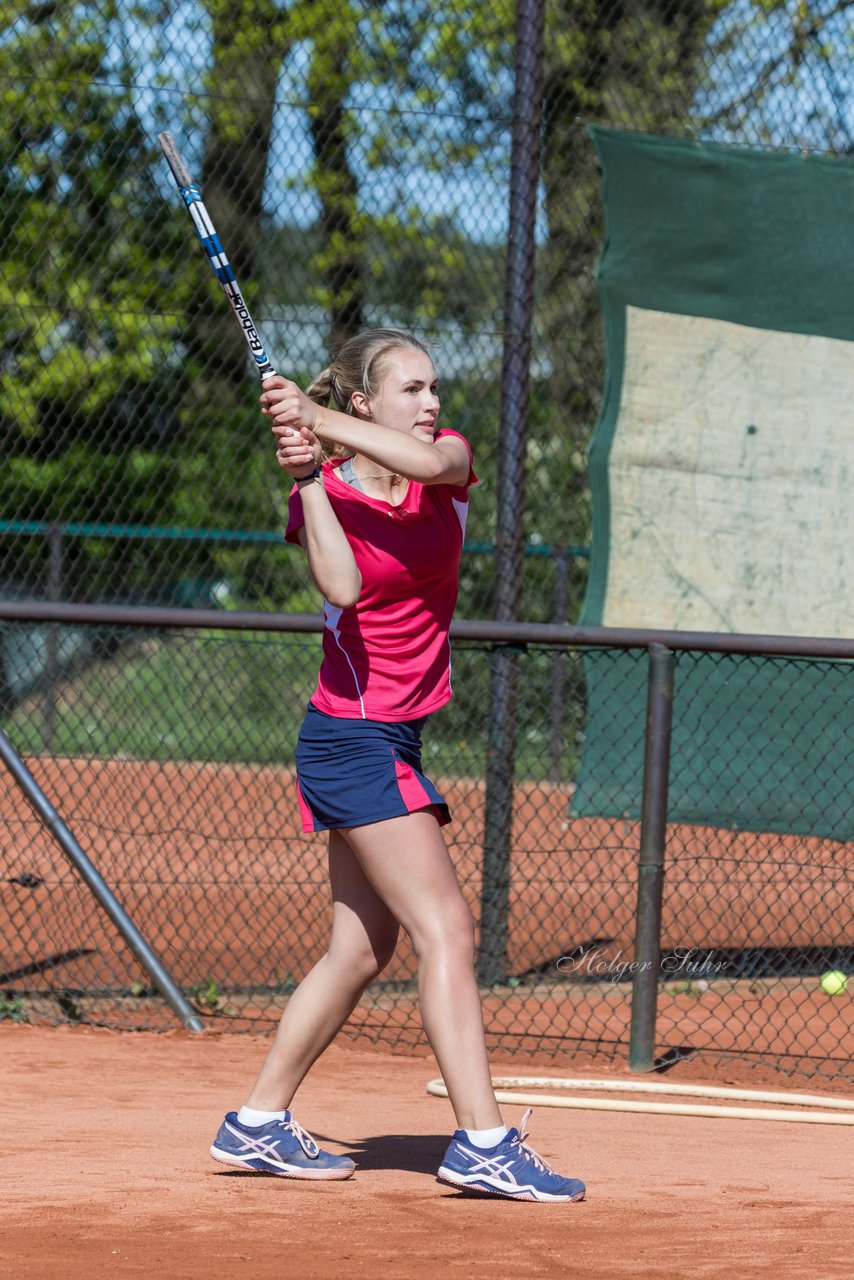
left=4, top=632, right=583, bottom=782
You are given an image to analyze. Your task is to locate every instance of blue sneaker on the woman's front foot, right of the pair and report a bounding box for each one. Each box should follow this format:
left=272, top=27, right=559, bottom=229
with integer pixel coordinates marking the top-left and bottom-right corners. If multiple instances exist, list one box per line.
left=438, top=1107, right=586, bottom=1203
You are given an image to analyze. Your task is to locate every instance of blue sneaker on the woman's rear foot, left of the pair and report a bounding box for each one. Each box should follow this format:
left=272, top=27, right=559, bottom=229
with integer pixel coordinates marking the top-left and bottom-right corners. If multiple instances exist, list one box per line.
left=210, top=1111, right=356, bottom=1180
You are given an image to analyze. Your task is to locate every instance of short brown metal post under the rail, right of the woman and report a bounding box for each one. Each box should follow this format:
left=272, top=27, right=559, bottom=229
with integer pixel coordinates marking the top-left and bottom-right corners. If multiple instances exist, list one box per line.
left=629, top=644, right=675, bottom=1071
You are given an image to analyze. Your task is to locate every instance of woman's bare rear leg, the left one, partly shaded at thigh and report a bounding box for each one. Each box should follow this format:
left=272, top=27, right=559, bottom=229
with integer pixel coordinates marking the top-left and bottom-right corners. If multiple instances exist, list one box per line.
left=247, top=831, right=398, bottom=1111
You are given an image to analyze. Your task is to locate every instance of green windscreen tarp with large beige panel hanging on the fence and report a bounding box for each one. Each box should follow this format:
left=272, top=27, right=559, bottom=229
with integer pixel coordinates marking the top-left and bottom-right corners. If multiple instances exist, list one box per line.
left=574, top=128, right=854, bottom=840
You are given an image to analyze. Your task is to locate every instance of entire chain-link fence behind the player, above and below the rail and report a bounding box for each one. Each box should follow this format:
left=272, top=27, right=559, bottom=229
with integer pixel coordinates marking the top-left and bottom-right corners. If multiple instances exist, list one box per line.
left=0, top=0, right=854, bottom=1075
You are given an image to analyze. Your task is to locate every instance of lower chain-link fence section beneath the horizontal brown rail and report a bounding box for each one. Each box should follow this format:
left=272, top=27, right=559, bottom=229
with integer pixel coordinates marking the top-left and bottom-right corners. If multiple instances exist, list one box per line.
left=0, top=606, right=854, bottom=1079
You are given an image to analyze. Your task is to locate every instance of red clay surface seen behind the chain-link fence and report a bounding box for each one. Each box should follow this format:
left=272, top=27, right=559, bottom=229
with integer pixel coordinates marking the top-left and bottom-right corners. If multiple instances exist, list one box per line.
left=0, top=758, right=854, bottom=1078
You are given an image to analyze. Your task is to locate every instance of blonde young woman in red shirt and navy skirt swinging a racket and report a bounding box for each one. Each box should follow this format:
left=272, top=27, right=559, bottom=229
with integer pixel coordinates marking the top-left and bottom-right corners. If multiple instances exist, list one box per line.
left=211, top=329, right=584, bottom=1202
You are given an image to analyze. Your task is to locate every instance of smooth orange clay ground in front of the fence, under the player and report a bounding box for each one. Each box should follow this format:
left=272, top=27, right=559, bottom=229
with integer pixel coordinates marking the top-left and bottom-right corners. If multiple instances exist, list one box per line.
left=0, top=1024, right=854, bottom=1280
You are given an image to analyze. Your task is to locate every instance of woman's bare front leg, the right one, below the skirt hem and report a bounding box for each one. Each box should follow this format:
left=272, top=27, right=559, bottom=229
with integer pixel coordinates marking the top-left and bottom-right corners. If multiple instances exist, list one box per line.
left=342, top=810, right=502, bottom=1129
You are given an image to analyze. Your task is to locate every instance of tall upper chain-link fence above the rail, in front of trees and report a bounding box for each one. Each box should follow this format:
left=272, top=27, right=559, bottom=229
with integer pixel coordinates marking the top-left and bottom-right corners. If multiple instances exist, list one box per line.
left=0, top=0, right=854, bottom=621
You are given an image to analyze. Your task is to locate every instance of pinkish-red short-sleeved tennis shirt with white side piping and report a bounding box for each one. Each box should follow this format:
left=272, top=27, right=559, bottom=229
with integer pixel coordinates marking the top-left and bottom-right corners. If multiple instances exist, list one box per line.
left=284, top=430, right=478, bottom=721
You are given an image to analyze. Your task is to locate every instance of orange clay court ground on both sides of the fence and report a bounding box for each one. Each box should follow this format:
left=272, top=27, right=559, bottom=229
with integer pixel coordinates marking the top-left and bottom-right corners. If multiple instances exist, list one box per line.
left=0, top=760, right=854, bottom=1280
